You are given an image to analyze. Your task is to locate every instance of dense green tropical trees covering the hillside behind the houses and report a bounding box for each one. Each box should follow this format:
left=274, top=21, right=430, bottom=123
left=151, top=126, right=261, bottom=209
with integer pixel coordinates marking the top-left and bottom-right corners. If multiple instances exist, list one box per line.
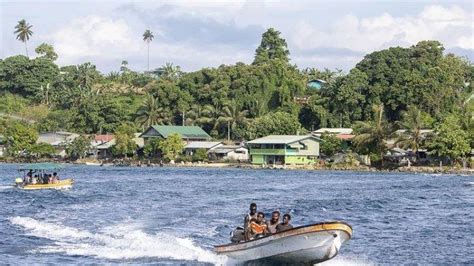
left=0, top=23, right=474, bottom=164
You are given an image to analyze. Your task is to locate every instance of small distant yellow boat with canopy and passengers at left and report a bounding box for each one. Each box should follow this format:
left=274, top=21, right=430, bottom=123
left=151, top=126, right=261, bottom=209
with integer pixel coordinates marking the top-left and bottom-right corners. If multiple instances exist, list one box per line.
left=15, top=163, right=74, bottom=190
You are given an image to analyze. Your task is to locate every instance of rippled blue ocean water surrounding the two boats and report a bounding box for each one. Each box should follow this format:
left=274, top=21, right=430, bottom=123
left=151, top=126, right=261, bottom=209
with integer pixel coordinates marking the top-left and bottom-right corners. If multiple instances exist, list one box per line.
left=0, top=164, right=474, bottom=265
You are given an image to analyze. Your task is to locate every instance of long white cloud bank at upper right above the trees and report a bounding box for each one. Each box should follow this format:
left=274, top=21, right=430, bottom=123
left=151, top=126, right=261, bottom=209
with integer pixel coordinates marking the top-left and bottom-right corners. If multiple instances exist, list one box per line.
left=290, top=5, right=474, bottom=53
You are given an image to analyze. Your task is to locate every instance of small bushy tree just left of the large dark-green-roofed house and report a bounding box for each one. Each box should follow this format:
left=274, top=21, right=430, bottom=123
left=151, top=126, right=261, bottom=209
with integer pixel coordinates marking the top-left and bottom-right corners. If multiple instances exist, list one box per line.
left=112, top=123, right=137, bottom=158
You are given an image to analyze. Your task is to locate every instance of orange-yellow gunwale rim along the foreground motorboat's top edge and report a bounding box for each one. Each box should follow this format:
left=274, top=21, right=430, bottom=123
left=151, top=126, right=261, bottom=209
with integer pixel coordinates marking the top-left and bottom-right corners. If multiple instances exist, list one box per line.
left=214, top=221, right=352, bottom=253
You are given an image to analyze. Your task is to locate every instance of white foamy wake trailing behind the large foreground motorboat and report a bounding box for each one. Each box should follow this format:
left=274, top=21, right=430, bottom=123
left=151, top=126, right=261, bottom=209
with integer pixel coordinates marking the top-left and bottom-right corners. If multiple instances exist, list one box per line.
left=9, top=217, right=225, bottom=264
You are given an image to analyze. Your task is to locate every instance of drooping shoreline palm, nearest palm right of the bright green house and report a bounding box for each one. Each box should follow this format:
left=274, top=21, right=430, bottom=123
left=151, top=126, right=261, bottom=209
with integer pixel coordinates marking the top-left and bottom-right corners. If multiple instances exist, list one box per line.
left=354, top=104, right=392, bottom=166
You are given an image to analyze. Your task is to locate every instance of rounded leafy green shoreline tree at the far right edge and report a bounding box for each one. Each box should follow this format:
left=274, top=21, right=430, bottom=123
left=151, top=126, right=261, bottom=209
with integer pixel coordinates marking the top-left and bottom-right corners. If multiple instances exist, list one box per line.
left=427, top=115, right=471, bottom=161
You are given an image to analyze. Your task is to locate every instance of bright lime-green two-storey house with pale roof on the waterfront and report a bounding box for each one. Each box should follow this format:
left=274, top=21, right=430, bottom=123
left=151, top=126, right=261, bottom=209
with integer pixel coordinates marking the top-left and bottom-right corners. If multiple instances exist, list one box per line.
left=247, top=135, right=321, bottom=165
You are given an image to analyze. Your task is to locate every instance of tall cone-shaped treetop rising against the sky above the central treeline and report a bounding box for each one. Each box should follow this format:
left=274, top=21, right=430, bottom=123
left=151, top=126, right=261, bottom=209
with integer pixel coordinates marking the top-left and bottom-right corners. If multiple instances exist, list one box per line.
left=253, top=28, right=290, bottom=65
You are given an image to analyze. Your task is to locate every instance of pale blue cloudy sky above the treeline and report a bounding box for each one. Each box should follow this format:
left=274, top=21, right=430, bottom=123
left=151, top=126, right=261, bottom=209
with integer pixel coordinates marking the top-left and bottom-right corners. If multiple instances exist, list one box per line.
left=0, top=0, right=474, bottom=73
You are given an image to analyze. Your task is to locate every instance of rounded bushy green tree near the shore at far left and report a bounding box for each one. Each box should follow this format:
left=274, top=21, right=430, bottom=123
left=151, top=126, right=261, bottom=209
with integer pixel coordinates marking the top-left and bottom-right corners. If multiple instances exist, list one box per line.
left=4, top=121, right=38, bottom=155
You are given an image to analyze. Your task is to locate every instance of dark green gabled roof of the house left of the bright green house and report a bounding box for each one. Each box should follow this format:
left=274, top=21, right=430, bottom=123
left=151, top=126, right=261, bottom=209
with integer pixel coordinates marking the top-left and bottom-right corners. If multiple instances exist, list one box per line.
left=140, top=125, right=211, bottom=143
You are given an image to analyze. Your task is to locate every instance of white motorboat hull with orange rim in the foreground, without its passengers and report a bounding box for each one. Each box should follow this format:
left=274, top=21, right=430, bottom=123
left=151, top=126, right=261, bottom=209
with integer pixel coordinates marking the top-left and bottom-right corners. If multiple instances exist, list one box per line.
left=215, top=222, right=352, bottom=265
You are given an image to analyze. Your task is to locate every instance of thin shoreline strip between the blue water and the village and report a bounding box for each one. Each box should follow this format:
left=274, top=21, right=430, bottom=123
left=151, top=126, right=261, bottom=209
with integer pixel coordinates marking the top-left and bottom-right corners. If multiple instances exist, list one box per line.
left=0, top=160, right=474, bottom=175
